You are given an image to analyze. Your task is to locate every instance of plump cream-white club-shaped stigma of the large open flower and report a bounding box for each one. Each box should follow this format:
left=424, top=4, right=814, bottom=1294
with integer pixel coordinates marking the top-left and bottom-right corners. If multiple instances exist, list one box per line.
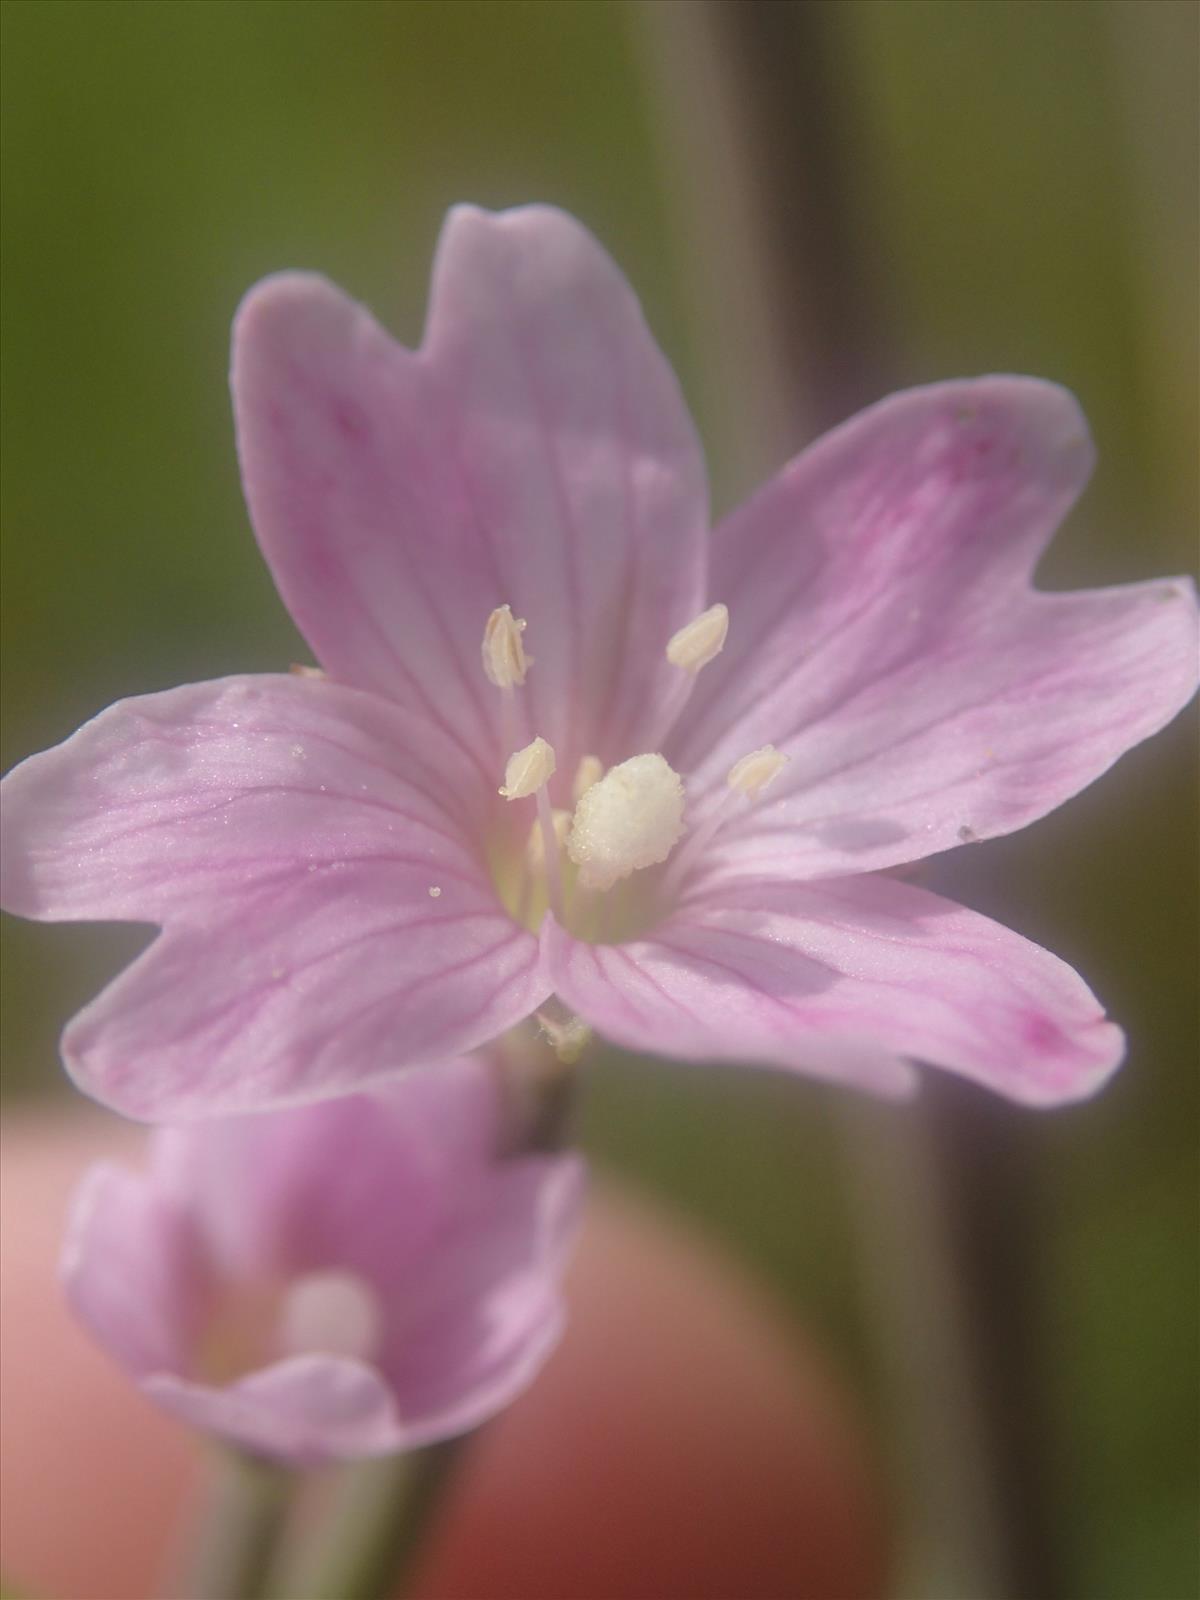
left=566, top=755, right=683, bottom=890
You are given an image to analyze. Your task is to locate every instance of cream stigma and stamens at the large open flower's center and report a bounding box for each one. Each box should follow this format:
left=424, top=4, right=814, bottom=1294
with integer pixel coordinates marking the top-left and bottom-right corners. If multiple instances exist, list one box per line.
left=482, top=605, right=787, bottom=944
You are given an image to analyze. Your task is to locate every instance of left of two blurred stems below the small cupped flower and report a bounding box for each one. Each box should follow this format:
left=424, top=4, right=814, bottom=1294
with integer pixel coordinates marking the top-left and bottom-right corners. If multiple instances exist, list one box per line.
left=182, top=1451, right=296, bottom=1600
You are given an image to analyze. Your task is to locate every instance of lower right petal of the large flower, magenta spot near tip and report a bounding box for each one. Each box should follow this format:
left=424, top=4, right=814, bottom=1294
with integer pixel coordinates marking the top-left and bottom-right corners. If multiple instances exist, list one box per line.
left=542, top=877, right=1123, bottom=1106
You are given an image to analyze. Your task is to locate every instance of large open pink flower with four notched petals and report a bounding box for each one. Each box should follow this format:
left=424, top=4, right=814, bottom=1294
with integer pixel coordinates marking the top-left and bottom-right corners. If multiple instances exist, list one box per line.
left=3, top=208, right=1197, bottom=1118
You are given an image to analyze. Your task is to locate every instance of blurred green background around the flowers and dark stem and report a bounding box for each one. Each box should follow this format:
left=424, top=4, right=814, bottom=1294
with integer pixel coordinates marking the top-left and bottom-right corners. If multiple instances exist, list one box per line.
left=3, top=0, right=1200, bottom=1600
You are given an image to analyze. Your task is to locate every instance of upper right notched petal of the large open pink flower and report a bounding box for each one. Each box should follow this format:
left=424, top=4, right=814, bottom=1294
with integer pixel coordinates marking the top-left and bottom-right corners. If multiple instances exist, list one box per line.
left=669, top=378, right=1200, bottom=878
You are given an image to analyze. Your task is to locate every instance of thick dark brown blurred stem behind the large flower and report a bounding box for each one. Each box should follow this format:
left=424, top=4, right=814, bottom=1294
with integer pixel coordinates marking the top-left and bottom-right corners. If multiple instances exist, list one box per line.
left=638, top=0, right=1062, bottom=1600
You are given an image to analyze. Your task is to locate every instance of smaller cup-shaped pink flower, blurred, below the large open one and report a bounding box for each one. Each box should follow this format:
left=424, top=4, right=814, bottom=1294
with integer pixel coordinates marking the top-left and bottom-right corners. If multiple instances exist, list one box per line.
left=62, top=1059, right=582, bottom=1462
